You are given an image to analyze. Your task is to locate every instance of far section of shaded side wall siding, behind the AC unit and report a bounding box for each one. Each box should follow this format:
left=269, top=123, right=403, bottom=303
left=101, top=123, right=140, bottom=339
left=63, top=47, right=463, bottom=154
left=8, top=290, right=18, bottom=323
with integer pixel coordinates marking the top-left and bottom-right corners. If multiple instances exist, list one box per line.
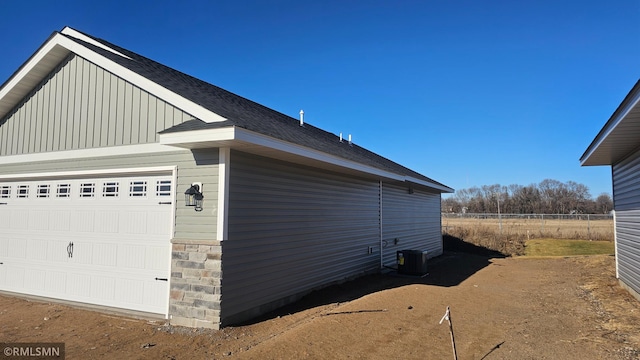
left=382, top=183, right=443, bottom=267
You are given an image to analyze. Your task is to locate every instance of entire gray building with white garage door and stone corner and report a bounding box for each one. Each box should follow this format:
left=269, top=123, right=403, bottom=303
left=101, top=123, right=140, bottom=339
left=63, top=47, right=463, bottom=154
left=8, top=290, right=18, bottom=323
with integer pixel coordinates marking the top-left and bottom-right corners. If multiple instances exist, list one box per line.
left=0, top=27, right=453, bottom=328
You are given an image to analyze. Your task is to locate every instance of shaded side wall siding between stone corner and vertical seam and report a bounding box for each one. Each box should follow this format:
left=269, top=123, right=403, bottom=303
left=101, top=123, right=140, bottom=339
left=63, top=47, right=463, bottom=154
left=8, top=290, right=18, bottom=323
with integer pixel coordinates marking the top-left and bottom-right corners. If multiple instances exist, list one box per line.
left=221, top=151, right=380, bottom=324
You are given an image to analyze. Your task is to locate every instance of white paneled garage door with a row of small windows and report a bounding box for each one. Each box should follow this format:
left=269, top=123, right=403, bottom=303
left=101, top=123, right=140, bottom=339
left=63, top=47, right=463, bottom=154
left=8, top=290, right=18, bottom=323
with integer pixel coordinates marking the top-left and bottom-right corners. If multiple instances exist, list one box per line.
left=0, top=174, right=173, bottom=315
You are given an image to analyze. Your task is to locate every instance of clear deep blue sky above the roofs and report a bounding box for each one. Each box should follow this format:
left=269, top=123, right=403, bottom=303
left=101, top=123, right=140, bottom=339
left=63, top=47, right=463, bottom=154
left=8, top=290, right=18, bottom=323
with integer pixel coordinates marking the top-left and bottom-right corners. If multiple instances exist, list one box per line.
left=0, top=0, right=640, bottom=197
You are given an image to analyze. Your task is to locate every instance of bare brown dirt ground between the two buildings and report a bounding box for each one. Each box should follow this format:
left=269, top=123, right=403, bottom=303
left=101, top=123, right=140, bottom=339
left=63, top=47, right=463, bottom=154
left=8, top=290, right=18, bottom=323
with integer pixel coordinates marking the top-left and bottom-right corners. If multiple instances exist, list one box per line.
left=0, top=253, right=640, bottom=359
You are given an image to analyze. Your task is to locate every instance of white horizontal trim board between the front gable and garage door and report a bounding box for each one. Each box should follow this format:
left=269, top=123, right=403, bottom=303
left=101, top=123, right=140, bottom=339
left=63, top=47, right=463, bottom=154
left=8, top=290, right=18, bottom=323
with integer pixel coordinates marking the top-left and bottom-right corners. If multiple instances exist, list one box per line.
left=0, top=143, right=185, bottom=165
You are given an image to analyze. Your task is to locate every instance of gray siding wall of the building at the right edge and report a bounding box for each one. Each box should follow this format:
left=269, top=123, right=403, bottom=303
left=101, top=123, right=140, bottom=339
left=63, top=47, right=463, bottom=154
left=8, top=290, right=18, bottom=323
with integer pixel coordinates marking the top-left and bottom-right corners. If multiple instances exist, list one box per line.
left=612, top=147, right=640, bottom=294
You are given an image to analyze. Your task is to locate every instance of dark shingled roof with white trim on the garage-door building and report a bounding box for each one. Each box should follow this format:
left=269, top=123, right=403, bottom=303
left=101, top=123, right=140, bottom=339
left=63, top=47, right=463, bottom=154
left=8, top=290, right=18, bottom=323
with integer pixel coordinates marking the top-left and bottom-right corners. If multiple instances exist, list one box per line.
left=0, top=27, right=453, bottom=192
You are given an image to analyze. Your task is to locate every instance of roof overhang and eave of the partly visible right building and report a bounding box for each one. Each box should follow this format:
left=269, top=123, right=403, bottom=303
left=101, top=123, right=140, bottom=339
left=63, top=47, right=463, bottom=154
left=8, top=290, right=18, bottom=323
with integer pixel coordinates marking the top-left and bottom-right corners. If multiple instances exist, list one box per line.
left=580, top=80, right=640, bottom=166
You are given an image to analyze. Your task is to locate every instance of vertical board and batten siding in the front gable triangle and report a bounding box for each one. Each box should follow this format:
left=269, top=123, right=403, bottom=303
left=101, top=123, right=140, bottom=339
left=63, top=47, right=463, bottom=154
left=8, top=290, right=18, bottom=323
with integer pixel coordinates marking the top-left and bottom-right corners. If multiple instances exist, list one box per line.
left=0, top=54, right=193, bottom=156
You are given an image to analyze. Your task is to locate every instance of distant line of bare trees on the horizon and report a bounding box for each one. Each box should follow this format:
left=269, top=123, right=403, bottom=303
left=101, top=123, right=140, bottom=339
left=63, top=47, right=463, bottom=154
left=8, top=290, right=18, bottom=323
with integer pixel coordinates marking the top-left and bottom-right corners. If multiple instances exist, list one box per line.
left=442, top=179, right=613, bottom=214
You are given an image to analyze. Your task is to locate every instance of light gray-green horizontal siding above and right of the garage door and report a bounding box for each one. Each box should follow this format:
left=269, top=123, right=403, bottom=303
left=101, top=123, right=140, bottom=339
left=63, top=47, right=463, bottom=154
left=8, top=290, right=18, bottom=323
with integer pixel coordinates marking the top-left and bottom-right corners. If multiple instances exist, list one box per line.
left=0, top=149, right=218, bottom=240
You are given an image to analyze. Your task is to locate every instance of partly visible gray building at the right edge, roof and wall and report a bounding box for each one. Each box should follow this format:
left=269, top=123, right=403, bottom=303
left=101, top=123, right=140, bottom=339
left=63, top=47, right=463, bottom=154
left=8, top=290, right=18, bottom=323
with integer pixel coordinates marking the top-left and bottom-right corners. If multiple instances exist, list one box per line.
left=580, top=81, right=640, bottom=300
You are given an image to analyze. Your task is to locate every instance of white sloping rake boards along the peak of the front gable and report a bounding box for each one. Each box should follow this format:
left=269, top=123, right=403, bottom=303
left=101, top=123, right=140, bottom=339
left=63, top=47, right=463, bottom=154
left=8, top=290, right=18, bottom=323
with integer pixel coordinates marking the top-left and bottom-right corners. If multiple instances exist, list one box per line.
left=0, top=27, right=226, bottom=123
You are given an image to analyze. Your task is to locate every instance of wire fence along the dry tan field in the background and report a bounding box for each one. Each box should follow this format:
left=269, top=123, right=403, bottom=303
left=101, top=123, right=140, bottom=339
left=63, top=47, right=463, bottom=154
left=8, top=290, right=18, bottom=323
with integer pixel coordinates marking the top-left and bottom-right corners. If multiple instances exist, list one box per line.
left=442, top=213, right=613, bottom=241
